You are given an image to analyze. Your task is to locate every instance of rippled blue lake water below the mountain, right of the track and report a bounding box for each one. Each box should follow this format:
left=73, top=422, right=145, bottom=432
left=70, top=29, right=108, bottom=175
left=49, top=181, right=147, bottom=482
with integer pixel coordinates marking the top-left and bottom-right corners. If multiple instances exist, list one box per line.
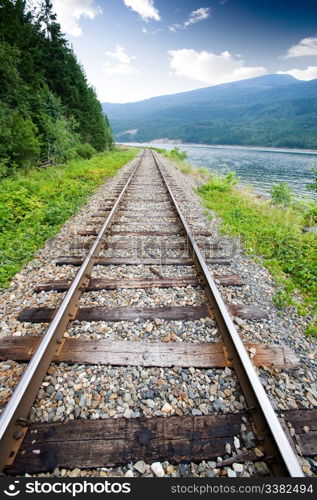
left=127, top=143, right=317, bottom=198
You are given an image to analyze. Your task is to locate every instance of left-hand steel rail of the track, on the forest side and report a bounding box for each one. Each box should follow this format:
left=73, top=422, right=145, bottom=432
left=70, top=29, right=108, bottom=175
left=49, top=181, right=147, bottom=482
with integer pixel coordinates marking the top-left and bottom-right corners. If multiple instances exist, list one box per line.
left=0, top=153, right=144, bottom=470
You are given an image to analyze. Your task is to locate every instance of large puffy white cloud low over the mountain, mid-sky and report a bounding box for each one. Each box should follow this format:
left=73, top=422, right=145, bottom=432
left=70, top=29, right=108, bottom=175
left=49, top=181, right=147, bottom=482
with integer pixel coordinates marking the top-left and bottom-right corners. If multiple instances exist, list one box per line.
left=168, top=49, right=267, bottom=85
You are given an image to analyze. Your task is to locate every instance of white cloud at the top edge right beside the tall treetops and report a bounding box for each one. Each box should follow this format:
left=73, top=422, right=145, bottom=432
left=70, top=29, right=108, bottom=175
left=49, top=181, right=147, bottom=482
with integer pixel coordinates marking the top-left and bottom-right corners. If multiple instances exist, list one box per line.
left=52, top=0, right=102, bottom=36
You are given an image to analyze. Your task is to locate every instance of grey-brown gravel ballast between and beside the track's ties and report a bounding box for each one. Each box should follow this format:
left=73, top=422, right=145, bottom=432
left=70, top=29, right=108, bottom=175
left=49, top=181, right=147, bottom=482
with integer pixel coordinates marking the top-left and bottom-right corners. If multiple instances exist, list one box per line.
left=0, top=149, right=317, bottom=477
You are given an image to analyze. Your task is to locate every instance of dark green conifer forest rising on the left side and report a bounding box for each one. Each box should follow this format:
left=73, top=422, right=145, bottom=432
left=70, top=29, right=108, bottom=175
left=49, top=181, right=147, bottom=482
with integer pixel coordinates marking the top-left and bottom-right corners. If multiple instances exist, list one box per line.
left=0, top=0, right=113, bottom=177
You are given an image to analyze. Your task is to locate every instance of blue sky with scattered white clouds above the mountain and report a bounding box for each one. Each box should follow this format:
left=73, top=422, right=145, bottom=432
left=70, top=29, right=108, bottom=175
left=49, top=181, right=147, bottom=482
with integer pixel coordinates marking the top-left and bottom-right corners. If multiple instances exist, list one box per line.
left=52, top=0, right=317, bottom=102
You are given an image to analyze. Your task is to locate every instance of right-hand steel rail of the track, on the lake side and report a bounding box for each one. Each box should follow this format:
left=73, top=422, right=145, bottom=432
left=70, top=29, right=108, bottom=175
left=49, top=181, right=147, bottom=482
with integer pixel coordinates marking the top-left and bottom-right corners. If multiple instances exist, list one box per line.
left=152, top=151, right=304, bottom=477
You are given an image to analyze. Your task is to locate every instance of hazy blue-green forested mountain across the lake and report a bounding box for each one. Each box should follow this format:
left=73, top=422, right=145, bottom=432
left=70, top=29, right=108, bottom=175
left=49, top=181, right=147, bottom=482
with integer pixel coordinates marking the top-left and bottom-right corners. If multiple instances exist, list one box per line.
left=103, top=74, right=317, bottom=149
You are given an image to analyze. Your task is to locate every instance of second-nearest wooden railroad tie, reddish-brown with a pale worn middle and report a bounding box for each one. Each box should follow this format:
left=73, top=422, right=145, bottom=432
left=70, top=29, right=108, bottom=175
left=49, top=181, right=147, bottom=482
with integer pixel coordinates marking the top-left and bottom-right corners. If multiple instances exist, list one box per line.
left=0, top=336, right=299, bottom=369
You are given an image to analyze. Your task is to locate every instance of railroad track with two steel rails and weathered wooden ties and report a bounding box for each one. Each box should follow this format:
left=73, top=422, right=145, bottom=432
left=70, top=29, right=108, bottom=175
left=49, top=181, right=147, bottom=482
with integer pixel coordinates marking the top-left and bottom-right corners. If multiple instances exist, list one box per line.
left=0, top=150, right=315, bottom=477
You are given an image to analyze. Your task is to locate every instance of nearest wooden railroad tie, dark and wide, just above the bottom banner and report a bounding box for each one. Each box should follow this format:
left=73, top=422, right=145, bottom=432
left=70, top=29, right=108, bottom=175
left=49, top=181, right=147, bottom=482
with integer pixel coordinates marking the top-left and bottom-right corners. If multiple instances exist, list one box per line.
left=5, top=410, right=317, bottom=474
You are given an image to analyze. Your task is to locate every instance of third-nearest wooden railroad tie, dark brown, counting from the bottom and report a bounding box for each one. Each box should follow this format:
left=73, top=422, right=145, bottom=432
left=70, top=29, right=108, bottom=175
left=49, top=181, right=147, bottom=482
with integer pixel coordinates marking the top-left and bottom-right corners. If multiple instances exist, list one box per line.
left=18, top=304, right=268, bottom=323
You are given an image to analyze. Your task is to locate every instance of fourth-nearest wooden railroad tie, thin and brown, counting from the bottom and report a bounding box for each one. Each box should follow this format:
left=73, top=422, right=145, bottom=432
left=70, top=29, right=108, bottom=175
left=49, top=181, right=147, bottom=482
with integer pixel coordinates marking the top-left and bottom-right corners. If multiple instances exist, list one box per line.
left=34, top=274, right=244, bottom=292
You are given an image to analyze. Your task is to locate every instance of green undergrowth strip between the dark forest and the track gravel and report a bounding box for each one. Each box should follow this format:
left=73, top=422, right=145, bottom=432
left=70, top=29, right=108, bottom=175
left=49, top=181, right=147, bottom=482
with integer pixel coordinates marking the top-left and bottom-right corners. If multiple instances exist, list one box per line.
left=0, top=149, right=138, bottom=287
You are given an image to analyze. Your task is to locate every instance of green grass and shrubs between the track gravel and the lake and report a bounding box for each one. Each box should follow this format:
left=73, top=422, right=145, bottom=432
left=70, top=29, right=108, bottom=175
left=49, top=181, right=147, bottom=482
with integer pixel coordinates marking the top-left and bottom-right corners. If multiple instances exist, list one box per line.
left=198, top=173, right=317, bottom=335
